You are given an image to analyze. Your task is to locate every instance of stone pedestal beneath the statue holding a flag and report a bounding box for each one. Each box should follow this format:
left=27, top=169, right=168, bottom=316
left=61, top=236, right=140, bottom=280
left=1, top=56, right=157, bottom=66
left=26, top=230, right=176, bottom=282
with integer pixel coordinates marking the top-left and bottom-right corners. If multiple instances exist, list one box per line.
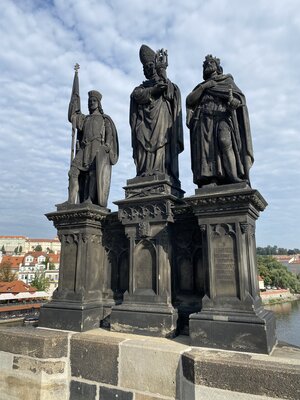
left=39, top=204, right=109, bottom=332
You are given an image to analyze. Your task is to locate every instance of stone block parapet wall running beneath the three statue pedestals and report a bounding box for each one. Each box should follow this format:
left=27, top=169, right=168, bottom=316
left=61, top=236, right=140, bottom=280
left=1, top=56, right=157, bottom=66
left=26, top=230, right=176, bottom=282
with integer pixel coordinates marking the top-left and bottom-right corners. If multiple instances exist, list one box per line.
left=0, top=327, right=300, bottom=400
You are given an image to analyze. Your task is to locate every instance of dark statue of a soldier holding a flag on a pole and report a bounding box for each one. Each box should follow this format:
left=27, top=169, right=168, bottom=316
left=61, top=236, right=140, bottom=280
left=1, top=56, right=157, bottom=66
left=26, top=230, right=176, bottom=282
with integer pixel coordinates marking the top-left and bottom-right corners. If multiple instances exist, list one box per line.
left=67, top=65, right=119, bottom=207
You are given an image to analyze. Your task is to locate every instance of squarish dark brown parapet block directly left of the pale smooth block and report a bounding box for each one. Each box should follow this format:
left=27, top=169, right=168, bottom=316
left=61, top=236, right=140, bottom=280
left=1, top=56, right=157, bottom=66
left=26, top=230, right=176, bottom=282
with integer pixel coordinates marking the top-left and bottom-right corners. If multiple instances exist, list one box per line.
left=70, top=333, right=124, bottom=385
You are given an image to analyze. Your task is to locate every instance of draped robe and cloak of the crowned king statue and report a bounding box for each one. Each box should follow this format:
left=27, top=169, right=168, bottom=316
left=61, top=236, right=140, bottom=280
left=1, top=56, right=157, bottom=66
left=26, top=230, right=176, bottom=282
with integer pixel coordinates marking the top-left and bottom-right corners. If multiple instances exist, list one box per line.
left=187, top=74, right=253, bottom=187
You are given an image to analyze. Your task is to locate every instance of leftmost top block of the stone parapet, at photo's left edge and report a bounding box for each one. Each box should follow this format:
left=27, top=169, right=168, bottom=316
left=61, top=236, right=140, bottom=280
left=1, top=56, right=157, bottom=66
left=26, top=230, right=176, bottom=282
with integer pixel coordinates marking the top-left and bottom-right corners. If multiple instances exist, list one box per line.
left=0, top=327, right=68, bottom=358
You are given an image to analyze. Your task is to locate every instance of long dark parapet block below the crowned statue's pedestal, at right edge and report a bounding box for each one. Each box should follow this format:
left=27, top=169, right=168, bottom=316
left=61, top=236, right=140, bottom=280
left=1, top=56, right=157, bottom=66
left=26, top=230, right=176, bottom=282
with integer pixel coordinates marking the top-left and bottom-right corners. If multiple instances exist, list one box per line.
left=182, top=349, right=300, bottom=400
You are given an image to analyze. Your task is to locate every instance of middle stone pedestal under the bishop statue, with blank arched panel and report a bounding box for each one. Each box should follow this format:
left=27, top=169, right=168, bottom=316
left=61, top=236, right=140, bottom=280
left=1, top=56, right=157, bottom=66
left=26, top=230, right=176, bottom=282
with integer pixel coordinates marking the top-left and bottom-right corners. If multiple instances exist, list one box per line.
left=110, top=175, right=183, bottom=337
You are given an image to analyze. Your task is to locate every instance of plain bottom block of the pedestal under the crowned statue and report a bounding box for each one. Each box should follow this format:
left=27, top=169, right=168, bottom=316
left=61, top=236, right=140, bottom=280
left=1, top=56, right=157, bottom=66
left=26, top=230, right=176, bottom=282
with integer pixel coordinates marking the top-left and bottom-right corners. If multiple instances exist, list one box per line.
left=189, top=309, right=276, bottom=354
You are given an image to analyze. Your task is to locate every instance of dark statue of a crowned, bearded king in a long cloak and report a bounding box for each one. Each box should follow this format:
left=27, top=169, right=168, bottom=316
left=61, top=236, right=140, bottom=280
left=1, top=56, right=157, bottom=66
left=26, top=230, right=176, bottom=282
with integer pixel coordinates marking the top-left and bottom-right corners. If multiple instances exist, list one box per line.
left=186, top=55, right=254, bottom=188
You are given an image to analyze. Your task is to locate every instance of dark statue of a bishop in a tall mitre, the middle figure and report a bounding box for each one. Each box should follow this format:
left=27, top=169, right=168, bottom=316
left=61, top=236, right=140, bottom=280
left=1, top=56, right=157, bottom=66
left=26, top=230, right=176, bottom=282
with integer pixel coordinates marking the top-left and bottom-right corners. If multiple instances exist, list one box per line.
left=130, top=45, right=183, bottom=181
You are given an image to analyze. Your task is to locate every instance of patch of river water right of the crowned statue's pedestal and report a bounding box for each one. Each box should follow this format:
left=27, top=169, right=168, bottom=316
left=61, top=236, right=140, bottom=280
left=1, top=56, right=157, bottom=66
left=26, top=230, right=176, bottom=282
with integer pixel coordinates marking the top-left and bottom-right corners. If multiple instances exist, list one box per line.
left=265, top=300, right=300, bottom=347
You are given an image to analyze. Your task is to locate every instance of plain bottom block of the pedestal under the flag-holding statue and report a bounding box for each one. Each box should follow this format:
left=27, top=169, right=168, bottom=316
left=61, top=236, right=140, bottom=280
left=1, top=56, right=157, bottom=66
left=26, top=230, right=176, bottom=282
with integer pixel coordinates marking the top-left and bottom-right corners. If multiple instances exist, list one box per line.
left=39, top=302, right=103, bottom=332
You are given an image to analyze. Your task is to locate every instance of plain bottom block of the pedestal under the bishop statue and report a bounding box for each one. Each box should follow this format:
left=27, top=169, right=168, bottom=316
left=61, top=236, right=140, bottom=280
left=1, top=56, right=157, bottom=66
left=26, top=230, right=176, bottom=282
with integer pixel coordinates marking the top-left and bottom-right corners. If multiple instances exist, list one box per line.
left=110, top=304, right=177, bottom=337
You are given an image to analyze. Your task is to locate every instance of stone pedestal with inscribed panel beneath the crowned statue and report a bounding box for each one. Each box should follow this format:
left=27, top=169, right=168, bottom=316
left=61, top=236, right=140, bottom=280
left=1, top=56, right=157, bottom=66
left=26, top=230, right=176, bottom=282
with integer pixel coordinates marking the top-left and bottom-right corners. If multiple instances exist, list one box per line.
left=186, top=183, right=276, bottom=353
